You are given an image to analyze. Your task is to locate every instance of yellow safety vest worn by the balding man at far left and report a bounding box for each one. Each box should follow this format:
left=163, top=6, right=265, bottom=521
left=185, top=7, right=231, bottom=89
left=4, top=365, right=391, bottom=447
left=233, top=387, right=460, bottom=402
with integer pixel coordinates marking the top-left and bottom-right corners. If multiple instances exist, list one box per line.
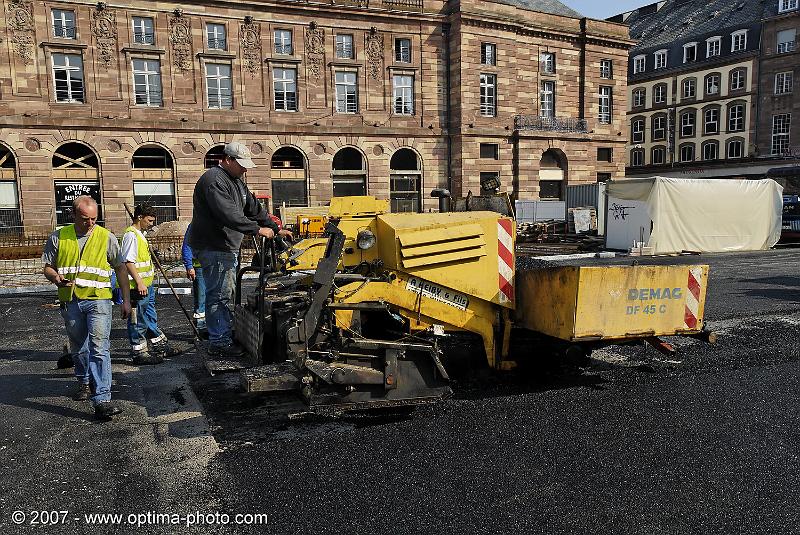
left=56, top=225, right=111, bottom=303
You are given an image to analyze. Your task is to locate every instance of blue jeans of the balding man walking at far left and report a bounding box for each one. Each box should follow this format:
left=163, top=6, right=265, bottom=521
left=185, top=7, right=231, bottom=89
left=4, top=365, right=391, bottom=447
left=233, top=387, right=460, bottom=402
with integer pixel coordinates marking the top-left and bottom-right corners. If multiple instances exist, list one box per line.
left=61, top=299, right=111, bottom=405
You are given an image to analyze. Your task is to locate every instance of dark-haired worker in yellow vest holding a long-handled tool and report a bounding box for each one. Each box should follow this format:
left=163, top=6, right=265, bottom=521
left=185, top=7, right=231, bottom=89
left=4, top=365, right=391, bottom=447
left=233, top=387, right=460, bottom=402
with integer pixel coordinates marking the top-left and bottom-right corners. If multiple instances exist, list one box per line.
left=120, top=204, right=175, bottom=365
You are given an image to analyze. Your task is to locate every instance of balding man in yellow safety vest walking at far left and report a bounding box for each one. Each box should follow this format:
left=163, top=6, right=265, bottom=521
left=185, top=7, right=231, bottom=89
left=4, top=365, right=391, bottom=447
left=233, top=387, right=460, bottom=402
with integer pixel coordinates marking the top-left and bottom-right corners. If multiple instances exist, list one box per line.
left=42, top=195, right=131, bottom=420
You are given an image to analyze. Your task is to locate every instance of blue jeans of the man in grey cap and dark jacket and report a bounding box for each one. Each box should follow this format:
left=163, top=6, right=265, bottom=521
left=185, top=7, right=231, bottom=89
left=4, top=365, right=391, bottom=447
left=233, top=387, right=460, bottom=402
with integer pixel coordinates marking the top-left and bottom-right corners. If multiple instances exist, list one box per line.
left=194, top=250, right=237, bottom=346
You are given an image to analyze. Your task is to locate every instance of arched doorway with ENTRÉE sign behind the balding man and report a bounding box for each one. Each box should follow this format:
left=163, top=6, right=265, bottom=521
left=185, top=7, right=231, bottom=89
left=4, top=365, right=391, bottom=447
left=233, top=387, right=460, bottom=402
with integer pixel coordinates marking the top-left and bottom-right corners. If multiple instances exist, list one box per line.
left=52, top=142, right=104, bottom=225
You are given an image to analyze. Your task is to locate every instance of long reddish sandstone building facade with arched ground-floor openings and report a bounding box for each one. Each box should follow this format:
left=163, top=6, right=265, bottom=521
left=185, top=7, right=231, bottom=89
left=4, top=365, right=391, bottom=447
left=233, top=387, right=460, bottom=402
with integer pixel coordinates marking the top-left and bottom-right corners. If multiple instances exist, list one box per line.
left=0, top=0, right=631, bottom=234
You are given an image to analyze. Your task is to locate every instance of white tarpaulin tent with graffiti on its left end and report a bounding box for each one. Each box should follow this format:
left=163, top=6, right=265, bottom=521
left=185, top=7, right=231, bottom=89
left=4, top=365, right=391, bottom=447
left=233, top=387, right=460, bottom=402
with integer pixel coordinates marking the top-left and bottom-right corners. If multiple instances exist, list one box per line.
left=606, top=177, right=783, bottom=254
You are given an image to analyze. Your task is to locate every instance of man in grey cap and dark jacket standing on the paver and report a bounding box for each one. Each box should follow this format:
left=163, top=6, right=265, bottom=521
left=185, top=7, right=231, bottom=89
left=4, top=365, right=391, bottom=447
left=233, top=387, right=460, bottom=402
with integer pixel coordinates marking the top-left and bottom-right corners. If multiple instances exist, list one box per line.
left=189, top=141, right=292, bottom=357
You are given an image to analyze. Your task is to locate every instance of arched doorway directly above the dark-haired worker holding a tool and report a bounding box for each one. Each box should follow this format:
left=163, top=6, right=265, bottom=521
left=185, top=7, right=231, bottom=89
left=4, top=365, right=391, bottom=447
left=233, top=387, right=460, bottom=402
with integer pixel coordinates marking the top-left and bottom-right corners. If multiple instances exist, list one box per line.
left=131, top=145, right=178, bottom=223
